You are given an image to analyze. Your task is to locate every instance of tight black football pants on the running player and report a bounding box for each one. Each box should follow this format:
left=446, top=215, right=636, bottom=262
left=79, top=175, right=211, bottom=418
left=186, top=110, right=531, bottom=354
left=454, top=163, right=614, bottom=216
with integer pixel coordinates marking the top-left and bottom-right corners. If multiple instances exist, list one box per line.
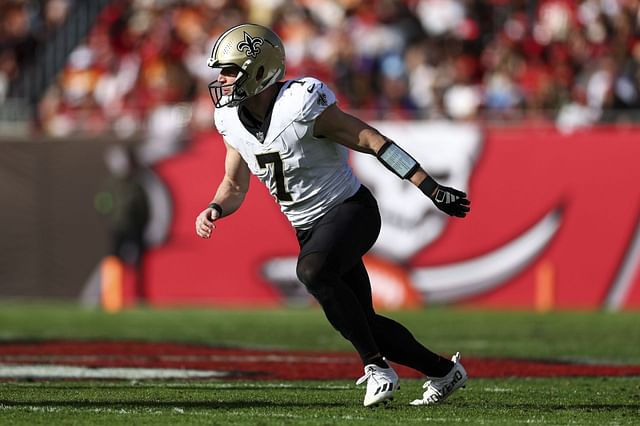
left=296, top=186, right=453, bottom=377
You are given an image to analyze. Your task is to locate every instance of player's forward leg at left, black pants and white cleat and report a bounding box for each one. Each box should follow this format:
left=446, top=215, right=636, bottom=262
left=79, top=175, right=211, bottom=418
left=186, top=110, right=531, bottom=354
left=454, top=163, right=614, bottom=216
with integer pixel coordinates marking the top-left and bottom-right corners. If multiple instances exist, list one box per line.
left=296, top=187, right=398, bottom=406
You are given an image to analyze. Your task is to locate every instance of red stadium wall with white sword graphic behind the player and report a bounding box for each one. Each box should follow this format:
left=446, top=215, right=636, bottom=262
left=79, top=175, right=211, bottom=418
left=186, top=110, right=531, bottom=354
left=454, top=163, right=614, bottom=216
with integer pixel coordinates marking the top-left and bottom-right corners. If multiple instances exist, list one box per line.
left=144, top=124, right=640, bottom=310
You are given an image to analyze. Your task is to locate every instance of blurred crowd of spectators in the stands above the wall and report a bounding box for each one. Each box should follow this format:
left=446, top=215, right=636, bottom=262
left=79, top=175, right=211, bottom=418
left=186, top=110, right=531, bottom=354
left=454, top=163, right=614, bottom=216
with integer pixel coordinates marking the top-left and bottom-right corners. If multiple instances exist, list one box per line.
left=0, top=0, right=640, bottom=135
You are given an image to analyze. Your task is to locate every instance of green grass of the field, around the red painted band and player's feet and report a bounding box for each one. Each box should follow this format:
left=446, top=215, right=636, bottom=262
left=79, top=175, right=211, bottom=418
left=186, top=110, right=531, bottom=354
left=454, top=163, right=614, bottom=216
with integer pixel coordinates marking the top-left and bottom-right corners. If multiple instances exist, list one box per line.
left=0, top=304, right=640, bottom=425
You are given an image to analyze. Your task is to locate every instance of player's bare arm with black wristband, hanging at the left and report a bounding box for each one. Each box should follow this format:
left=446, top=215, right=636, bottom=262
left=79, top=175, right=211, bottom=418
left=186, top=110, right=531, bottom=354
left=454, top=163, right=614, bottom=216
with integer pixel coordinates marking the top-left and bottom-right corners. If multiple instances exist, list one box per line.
left=196, top=142, right=250, bottom=238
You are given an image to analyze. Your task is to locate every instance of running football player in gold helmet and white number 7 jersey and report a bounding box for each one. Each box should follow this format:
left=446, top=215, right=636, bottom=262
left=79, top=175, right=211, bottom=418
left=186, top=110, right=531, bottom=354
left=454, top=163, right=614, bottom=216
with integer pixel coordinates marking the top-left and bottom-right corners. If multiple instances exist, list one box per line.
left=195, top=24, right=470, bottom=406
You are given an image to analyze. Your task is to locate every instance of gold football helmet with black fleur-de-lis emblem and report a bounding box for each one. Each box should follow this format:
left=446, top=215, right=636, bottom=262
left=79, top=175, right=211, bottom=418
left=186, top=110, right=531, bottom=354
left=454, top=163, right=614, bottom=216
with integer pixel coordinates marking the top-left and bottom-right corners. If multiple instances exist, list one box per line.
left=207, top=24, right=285, bottom=108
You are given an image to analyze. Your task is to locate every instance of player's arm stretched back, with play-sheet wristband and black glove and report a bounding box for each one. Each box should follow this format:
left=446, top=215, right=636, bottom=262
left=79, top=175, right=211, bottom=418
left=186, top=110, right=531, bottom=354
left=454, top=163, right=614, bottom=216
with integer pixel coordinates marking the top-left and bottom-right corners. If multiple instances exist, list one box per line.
left=314, top=104, right=470, bottom=217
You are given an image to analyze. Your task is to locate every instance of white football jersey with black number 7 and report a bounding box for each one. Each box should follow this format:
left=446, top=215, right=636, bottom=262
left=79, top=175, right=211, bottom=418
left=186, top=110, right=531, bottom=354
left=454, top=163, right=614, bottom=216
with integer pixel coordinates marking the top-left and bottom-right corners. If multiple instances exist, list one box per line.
left=215, top=77, right=360, bottom=229
